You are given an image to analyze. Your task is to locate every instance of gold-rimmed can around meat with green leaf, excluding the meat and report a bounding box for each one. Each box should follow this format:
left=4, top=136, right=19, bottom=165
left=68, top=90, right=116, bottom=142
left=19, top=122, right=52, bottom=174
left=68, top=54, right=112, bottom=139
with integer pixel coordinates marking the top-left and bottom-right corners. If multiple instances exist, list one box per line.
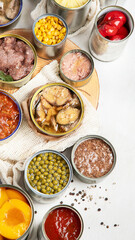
left=0, top=33, right=37, bottom=90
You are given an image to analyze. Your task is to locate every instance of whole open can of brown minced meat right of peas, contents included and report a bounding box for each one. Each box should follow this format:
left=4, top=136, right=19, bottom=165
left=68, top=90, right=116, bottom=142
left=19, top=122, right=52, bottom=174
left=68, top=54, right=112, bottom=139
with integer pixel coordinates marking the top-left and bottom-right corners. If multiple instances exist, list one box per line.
left=71, top=135, right=116, bottom=183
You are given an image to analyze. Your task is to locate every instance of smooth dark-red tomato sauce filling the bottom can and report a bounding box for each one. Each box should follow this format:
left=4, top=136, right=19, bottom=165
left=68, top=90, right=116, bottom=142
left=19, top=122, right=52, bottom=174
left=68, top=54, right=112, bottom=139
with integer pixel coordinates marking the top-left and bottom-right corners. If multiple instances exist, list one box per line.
left=44, top=207, right=81, bottom=240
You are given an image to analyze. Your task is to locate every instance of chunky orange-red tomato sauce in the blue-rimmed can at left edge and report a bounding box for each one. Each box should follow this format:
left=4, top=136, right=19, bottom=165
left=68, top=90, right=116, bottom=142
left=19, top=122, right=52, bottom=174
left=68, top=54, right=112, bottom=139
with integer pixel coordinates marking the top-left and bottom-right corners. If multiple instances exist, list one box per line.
left=0, top=93, right=19, bottom=139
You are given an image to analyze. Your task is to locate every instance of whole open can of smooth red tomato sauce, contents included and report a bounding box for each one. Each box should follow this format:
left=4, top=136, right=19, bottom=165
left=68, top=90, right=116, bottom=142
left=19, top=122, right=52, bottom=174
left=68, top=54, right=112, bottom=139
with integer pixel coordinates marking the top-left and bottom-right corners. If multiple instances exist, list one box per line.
left=38, top=205, right=84, bottom=240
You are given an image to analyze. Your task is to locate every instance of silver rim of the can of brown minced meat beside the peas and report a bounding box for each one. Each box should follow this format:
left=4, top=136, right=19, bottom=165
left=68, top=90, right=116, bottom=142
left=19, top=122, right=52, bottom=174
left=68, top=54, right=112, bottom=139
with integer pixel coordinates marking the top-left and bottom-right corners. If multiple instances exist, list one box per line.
left=71, top=135, right=116, bottom=181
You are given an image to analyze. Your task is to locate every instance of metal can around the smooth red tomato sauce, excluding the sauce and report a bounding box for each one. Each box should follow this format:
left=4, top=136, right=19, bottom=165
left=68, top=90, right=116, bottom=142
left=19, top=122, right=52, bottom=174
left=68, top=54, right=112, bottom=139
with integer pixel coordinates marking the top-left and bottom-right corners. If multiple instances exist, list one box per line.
left=37, top=205, right=84, bottom=240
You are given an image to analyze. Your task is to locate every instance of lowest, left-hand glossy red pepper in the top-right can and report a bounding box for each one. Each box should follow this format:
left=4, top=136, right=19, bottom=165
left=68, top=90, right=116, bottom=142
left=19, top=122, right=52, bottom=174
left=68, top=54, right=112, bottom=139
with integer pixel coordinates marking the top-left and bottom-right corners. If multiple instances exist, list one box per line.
left=98, top=23, right=118, bottom=37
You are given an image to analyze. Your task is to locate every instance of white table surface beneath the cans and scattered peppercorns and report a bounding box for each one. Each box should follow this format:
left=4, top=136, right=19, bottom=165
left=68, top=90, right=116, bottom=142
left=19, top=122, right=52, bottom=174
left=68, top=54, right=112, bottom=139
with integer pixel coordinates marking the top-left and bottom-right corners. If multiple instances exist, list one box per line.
left=2, top=0, right=135, bottom=240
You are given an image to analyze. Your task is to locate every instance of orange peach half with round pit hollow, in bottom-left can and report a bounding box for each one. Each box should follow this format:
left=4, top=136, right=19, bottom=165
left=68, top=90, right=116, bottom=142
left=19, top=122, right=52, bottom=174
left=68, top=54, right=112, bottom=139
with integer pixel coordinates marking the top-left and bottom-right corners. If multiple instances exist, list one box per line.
left=0, top=199, right=31, bottom=239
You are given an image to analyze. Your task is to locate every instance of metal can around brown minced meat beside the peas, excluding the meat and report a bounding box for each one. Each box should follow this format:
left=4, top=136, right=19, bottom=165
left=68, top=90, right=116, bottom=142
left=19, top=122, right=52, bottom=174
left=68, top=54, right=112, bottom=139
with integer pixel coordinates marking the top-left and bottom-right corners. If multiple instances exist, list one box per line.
left=71, top=135, right=116, bottom=184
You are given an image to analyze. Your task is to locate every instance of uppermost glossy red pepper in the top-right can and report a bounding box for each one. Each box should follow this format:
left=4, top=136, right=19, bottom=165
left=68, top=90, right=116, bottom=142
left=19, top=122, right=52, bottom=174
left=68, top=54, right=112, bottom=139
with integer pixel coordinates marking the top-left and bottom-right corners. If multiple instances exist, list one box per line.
left=104, top=11, right=127, bottom=25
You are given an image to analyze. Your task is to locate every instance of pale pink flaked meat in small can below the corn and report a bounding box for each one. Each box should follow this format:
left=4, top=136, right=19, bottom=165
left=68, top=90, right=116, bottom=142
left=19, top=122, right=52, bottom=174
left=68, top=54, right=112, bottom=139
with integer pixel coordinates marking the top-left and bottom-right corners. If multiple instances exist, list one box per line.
left=61, top=52, right=92, bottom=81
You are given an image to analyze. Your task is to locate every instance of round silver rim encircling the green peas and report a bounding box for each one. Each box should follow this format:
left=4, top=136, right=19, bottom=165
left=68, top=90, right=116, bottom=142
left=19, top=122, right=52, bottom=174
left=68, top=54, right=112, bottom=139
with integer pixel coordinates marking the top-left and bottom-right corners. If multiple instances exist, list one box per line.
left=24, top=150, right=73, bottom=199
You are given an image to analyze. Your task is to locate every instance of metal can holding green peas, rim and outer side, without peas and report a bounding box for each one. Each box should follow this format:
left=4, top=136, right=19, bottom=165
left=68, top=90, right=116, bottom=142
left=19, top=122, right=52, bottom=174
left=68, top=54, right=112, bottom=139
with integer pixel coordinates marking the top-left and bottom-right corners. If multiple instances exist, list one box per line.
left=24, top=150, right=73, bottom=203
